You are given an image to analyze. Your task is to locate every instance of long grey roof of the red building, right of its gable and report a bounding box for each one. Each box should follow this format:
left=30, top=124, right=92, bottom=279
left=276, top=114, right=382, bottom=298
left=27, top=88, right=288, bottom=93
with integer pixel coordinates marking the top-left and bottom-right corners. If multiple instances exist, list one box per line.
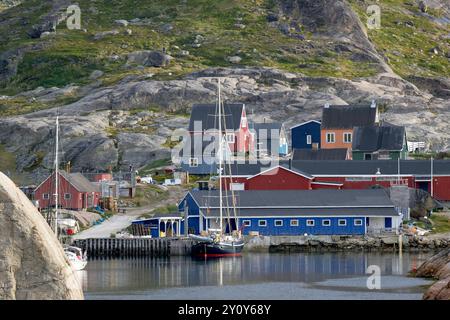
left=292, top=160, right=450, bottom=176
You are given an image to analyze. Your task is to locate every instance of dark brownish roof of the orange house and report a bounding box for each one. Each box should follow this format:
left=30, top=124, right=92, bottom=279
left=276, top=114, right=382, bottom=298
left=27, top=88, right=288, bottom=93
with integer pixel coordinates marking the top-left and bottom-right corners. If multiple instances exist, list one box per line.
left=322, top=105, right=376, bottom=129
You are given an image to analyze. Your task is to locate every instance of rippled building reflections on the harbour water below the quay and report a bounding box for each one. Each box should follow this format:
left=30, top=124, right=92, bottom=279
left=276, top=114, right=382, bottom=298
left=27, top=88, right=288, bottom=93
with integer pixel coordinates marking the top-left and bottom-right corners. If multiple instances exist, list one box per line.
left=80, top=253, right=429, bottom=298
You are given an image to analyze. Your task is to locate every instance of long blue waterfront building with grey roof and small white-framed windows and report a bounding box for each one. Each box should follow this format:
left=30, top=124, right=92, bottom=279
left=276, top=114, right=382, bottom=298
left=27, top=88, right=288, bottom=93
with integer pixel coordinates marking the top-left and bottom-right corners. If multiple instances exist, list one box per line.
left=179, top=189, right=402, bottom=236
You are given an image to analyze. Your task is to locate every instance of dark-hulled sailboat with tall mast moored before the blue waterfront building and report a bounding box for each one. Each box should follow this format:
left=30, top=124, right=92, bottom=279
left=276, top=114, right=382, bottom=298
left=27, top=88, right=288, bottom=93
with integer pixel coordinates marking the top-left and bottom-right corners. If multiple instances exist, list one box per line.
left=190, top=79, right=244, bottom=257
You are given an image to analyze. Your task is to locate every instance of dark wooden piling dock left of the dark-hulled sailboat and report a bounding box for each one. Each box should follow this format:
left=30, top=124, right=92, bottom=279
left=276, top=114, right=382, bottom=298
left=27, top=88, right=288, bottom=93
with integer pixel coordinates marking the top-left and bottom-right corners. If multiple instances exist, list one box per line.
left=73, top=238, right=192, bottom=258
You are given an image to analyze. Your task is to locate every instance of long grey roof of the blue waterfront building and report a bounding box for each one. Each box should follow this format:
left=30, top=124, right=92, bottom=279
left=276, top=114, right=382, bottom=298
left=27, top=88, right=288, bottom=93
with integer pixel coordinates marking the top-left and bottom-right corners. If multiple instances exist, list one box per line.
left=191, top=189, right=394, bottom=209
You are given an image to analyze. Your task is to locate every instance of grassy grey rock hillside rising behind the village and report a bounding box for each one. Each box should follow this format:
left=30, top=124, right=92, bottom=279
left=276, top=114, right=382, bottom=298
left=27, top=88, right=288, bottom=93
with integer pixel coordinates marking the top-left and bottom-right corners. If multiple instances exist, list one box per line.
left=0, top=0, right=450, bottom=181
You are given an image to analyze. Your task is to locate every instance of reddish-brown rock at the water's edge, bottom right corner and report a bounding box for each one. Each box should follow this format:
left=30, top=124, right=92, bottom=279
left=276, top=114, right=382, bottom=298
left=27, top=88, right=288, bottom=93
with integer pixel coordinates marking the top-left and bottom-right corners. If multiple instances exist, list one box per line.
left=416, top=249, right=450, bottom=300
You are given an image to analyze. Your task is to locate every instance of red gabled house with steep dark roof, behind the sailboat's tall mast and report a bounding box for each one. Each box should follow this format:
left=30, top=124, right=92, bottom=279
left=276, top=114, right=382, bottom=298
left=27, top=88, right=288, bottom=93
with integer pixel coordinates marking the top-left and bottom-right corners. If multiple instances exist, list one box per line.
left=189, top=103, right=255, bottom=154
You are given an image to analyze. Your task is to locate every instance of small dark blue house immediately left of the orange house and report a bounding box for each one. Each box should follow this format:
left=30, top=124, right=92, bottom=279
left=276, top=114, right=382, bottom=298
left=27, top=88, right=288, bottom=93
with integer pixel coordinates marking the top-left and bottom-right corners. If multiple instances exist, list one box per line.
left=291, top=120, right=321, bottom=150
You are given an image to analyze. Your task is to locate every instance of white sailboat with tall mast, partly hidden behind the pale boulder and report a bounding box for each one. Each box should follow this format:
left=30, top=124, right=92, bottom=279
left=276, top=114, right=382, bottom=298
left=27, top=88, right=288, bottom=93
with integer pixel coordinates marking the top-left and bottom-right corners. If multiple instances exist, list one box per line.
left=54, top=117, right=87, bottom=271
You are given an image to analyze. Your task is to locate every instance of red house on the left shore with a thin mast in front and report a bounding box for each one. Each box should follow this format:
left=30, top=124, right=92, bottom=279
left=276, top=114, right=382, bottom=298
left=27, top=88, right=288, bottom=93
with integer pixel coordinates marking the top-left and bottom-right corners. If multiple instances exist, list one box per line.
left=34, top=171, right=100, bottom=210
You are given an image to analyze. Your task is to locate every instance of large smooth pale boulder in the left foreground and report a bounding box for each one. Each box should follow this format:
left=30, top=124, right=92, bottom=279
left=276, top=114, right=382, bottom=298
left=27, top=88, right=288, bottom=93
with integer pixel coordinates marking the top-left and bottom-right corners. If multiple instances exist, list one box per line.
left=0, top=172, right=83, bottom=300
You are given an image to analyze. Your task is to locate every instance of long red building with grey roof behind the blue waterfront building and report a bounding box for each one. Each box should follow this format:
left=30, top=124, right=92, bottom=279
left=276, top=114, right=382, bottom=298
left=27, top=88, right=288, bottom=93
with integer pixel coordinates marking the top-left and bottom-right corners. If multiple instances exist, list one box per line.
left=223, top=160, right=450, bottom=201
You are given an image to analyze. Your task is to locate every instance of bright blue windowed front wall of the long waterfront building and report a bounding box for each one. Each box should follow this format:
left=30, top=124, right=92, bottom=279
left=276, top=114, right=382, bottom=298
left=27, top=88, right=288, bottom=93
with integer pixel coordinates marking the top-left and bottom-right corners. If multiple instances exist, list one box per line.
left=240, top=217, right=365, bottom=235
